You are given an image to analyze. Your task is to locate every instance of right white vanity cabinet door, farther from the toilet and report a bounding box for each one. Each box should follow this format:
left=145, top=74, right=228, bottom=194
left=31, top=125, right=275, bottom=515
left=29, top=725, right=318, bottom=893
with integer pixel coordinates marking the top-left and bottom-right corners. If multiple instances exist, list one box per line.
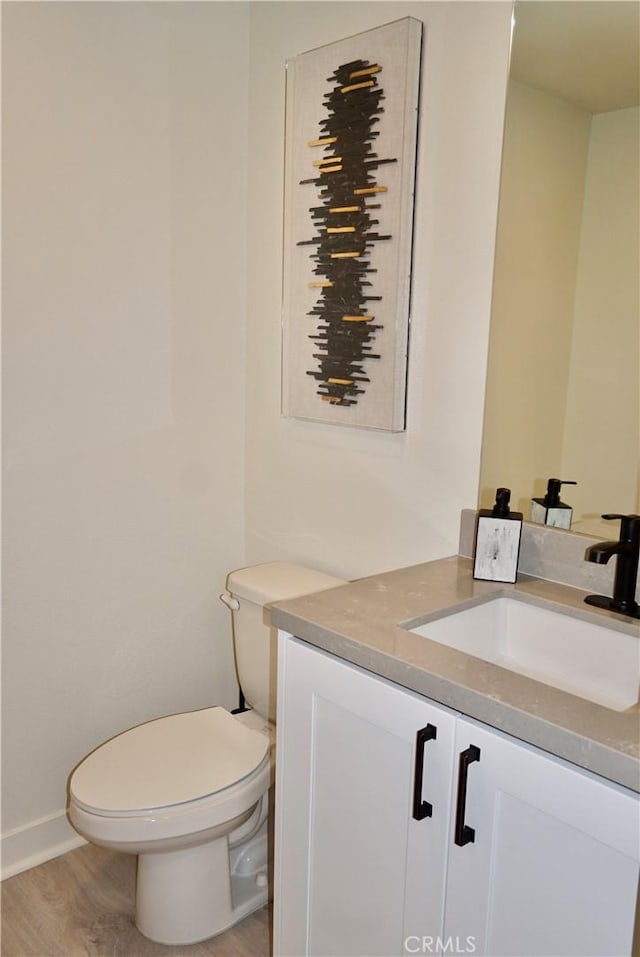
left=445, top=718, right=640, bottom=957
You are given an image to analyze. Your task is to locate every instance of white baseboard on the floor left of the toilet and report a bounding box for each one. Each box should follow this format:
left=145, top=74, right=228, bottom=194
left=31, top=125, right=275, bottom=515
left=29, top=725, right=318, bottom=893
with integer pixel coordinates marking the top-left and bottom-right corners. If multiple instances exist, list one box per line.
left=0, top=811, right=87, bottom=880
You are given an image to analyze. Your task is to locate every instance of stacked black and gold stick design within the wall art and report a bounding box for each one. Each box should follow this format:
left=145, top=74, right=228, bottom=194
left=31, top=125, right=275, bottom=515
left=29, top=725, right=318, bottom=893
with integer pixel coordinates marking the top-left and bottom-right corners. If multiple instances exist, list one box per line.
left=298, top=60, right=396, bottom=405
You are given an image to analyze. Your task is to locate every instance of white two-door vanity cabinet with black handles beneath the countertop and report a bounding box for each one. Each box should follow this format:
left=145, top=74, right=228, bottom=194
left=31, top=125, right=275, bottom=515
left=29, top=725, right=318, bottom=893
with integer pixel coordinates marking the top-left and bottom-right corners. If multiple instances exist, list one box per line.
left=274, top=635, right=640, bottom=957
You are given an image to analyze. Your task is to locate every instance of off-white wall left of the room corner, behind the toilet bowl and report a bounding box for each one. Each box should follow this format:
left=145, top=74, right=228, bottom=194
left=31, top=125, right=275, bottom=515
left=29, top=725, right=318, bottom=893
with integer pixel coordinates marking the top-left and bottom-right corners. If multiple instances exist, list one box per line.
left=2, top=3, right=249, bottom=872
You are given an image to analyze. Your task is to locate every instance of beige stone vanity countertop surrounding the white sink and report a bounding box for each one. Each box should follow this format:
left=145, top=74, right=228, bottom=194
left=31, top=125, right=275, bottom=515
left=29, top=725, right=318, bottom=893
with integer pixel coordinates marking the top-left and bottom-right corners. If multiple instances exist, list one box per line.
left=271, top=556, right=640, bottom=791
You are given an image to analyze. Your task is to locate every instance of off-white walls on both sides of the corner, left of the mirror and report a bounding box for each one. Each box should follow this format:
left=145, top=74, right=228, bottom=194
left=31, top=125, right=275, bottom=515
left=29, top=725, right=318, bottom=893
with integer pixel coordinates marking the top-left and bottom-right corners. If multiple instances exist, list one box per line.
left=3, top=2, right=510, bottom=872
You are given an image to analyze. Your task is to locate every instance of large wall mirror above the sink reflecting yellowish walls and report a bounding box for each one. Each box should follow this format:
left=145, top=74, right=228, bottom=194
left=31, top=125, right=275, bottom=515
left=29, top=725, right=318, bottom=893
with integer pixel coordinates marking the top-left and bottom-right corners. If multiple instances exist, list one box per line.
left=479, top=0, right=640, bottom=538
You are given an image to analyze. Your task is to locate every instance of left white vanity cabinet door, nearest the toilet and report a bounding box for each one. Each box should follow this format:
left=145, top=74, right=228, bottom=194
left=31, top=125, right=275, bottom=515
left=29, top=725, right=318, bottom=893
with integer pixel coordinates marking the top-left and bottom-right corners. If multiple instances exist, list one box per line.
left=274, top=635, right=455, bottom=957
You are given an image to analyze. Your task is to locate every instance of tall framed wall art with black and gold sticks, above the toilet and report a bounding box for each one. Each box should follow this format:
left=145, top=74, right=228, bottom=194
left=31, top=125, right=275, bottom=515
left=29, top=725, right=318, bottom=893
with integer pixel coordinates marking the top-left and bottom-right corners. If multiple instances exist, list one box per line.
left=282, top=17, right=422, bottom=432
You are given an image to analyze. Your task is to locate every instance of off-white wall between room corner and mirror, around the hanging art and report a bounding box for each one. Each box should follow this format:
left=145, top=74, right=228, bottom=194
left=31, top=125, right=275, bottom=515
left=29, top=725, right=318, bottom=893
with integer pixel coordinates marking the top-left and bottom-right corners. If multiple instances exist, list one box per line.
left=246, top=2, right=511, bottom=578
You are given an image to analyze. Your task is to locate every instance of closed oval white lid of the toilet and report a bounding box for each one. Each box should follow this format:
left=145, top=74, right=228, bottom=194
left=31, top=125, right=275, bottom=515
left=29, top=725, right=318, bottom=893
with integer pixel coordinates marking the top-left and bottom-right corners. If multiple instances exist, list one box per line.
left=69, top=708, right=269, bottom=814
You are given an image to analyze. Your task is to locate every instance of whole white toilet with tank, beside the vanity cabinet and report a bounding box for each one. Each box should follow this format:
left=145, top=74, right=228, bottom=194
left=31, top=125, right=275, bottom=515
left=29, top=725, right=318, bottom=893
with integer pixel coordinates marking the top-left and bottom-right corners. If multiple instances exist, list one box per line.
left=68, top=562, right=344, bottom=945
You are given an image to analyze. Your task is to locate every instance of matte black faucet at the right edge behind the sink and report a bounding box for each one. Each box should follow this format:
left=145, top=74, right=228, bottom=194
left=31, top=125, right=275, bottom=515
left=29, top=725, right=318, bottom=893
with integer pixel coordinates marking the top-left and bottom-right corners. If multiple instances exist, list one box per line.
left=584, top=515, right=640, bottom=618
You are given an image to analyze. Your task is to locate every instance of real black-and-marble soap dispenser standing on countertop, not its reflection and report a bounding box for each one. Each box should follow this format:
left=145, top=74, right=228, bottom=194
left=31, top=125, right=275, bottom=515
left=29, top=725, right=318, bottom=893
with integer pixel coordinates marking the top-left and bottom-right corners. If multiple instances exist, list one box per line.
left=473, top=488, right=522, bottom=582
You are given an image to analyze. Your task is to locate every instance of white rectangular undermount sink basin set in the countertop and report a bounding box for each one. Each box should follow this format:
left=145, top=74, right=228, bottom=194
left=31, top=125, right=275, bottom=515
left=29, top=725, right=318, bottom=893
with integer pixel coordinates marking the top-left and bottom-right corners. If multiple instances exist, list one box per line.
left=409, top=597, right=640, bottom=711
